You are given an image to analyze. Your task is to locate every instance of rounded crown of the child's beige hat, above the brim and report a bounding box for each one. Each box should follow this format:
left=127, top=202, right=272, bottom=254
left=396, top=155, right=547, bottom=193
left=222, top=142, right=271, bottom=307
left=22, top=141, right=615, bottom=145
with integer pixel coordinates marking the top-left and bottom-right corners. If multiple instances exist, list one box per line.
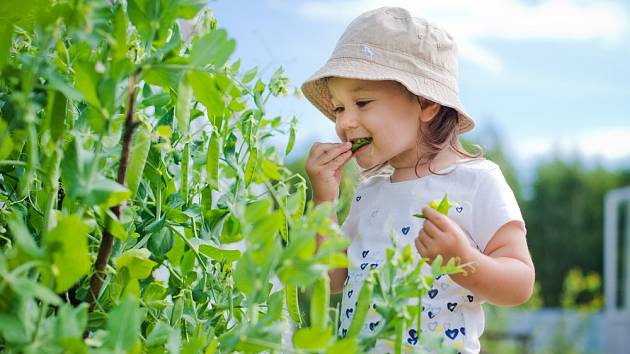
left=331, top=7, right=458, bottom=75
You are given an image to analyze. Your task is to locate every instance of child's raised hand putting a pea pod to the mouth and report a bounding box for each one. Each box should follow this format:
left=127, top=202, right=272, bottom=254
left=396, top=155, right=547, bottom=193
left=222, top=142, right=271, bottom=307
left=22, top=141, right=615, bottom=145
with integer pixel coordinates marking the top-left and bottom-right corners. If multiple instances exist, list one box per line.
left=305, top=142, right=352, bottom=203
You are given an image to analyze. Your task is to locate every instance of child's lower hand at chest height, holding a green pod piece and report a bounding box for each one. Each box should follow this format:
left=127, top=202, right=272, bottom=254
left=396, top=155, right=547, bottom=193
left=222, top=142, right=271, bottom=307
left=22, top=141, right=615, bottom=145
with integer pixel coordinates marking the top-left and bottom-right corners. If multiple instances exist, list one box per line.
left=415, top=207, right=473, bottom=263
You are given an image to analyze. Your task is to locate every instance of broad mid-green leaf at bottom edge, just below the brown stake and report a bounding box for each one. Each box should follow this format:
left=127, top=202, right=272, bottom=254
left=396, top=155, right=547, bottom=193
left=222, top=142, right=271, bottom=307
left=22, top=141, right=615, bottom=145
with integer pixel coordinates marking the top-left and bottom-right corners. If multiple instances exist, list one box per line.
left=106, top=296, right=144, bottom=352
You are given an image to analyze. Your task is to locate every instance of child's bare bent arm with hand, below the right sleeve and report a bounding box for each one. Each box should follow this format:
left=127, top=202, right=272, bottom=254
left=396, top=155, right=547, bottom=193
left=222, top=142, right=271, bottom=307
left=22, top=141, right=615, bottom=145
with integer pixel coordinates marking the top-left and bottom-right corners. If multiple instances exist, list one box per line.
left=415, top=208, right=535, bottom=306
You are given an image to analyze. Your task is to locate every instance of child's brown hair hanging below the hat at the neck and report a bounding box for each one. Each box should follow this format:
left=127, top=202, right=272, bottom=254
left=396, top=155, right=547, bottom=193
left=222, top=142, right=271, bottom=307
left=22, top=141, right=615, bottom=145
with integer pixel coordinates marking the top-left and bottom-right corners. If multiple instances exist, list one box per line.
left=360, top=88, right=484, bottom=180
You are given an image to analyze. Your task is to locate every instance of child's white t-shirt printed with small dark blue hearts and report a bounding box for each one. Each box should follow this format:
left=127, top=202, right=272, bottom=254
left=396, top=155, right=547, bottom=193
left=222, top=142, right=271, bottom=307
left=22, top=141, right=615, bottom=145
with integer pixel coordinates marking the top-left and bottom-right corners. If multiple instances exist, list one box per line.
left=339, top=159, right=524, bottom=354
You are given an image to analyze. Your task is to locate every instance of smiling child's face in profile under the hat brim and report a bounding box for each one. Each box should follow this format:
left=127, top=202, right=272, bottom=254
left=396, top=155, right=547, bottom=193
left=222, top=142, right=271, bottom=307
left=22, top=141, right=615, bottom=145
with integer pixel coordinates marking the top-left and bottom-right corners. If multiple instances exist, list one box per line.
left=328, top=77, right=421, bottom=168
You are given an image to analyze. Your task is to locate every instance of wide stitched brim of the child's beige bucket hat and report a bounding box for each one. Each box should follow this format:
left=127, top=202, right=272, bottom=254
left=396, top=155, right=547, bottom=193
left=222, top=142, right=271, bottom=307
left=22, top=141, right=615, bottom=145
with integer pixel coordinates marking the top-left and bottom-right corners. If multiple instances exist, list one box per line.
left=301, top=57, right=475, bottom=134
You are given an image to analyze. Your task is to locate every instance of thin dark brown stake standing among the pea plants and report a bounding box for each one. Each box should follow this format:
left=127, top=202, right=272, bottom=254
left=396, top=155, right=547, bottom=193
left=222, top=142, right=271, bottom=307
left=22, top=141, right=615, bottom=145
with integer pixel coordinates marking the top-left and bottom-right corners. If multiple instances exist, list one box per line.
left=88, top=74, right=139, bottom=312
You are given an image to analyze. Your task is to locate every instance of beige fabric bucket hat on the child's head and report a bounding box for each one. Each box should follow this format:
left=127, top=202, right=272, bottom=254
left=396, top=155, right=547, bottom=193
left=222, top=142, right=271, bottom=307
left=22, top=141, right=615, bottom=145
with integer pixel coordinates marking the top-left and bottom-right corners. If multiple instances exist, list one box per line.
left=302, top=7, right=475, bottom=133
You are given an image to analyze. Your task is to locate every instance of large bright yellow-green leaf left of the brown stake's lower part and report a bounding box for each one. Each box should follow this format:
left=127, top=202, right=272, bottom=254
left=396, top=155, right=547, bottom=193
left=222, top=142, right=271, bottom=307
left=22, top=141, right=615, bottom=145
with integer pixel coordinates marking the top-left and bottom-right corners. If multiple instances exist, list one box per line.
left=44, top=214, right=90, bottom=293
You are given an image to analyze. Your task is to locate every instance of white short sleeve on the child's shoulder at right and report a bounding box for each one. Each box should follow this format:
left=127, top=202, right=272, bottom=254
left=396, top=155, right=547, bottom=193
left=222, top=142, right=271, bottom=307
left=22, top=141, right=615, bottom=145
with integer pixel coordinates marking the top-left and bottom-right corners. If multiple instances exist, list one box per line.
left=471, top=165, right=525, bottom=251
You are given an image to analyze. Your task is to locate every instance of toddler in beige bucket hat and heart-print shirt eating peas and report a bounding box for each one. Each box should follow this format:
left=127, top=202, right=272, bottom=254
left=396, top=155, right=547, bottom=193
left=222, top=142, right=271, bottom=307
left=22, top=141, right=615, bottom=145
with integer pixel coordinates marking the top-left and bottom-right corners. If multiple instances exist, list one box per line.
left=302, top=7, right=534, bottom=354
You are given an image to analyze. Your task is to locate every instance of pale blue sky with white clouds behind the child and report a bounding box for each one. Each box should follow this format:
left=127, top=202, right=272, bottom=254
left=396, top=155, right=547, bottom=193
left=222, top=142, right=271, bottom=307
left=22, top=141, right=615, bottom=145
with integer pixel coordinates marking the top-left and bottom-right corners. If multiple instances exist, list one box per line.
left=209, top=0, right=630, bottom=171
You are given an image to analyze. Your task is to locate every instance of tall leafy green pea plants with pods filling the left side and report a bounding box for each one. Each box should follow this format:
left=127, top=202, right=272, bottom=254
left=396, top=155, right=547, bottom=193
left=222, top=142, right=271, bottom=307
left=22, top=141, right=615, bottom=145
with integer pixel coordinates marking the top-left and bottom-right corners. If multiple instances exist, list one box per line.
left=0, top=0, right=460, bottom=353
